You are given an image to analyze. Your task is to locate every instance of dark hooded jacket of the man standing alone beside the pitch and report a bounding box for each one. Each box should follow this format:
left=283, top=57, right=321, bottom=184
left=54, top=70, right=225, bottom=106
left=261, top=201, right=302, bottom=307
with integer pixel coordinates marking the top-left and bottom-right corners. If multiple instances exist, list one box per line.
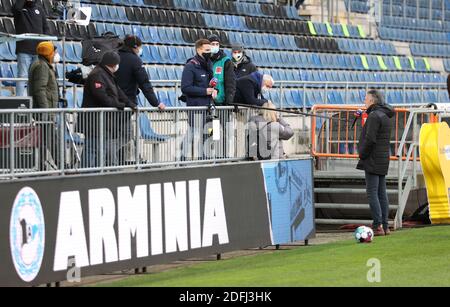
left=357, top=104, right=395, bottom=176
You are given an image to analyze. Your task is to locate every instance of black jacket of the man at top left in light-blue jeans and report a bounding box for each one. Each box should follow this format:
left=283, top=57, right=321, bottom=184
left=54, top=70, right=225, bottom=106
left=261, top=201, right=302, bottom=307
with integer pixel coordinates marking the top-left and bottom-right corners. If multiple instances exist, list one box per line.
left=13, top=0, right=49, bottom=55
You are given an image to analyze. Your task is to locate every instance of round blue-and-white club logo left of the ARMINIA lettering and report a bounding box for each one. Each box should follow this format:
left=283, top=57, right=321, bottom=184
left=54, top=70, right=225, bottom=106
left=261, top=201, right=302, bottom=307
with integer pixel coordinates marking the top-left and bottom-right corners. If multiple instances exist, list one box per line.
left=9, top=187, right=45, bottom=282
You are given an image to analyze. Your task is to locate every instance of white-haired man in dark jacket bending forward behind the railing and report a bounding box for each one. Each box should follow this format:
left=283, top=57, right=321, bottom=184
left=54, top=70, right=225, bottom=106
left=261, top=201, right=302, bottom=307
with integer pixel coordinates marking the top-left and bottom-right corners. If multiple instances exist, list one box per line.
left=234, top=72, right=274, bottom=107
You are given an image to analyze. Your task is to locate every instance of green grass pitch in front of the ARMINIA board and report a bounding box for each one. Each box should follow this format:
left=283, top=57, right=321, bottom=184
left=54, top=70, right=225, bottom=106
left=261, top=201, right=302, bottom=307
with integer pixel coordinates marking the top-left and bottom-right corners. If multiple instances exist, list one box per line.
left=95, top=226, right=450, bottom=287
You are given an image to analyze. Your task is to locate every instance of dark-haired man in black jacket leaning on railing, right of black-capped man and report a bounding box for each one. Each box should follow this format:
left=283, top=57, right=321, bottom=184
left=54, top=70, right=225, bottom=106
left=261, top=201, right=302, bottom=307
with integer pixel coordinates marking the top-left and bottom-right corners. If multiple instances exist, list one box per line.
left=115, top=35, right=166, bottom=110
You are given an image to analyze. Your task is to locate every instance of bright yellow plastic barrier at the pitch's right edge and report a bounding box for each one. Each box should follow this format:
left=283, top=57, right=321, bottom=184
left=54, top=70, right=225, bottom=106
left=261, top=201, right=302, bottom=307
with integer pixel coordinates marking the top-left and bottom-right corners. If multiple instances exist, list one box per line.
left=419, top=122, right=450, bottom=224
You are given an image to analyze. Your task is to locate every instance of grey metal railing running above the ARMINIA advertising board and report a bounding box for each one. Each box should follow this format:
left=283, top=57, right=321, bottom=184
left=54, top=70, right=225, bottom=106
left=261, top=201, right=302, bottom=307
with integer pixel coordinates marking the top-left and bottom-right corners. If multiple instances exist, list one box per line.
left=0, top=107, right=256, bottom=178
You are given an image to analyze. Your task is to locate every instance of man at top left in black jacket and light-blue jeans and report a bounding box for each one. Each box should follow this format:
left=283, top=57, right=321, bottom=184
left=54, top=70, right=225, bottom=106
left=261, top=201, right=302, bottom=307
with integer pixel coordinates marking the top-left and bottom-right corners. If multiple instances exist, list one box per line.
left=13, top=0, right=49, bottom=96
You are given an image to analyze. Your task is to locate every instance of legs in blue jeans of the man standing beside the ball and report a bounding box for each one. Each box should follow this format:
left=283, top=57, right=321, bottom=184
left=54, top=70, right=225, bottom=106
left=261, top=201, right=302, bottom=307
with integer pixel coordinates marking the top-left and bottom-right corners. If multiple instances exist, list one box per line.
left=366, top=172, right=389, bottom=229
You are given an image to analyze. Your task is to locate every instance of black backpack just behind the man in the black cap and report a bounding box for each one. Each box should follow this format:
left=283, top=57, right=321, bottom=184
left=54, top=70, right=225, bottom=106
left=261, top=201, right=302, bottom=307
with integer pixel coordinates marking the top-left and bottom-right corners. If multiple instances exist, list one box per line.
left=81, top=32, right=123, bottom=66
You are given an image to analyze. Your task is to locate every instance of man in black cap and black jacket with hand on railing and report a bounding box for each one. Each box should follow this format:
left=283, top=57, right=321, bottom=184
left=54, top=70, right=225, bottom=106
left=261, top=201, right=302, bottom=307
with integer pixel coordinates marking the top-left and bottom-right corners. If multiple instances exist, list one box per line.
left=80, top=51, right=136, bottom=167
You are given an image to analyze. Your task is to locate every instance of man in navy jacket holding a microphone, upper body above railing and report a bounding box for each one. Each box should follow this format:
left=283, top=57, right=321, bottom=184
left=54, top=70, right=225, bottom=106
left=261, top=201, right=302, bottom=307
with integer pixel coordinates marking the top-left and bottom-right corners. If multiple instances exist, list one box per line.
left=181, top=39, right=217, bottom=107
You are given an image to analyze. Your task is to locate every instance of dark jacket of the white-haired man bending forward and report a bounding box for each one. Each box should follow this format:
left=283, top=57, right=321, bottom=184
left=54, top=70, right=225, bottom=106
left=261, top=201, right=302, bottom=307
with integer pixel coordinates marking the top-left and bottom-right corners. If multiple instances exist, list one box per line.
left=234, top=72, right=268, bottom=106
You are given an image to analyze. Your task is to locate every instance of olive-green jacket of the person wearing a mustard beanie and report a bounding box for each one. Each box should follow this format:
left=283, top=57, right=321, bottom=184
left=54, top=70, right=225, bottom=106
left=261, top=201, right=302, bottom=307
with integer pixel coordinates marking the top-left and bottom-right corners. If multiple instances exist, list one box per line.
left=28, top=56, right=59, bottom=109
